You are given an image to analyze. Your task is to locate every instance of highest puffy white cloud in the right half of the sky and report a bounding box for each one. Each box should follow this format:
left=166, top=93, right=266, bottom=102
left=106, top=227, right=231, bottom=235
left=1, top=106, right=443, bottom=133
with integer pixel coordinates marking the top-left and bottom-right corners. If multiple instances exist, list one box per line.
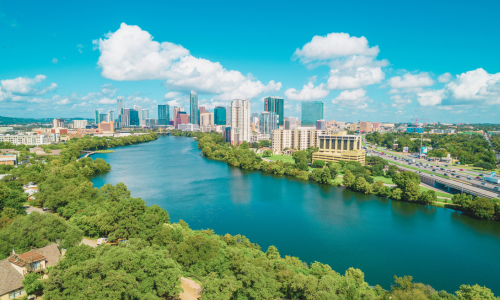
left=294, top=32, right=380, bottom=63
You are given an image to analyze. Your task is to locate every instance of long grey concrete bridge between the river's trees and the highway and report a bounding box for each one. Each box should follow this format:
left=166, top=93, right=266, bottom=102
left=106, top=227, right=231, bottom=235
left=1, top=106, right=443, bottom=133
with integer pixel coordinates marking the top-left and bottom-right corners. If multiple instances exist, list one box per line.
left=398, top=165, right=500, bottom=199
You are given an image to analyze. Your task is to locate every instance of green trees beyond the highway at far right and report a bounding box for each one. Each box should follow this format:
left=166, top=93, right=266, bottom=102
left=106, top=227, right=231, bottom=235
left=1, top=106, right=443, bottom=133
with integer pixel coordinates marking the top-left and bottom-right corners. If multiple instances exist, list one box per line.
left=366, top=132, right=497, bottom=165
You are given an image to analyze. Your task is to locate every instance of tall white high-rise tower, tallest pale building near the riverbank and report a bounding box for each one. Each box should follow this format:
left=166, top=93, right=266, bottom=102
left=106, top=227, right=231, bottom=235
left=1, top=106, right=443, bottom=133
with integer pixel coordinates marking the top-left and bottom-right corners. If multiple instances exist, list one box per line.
left=231, top=99, right=252, bottom=145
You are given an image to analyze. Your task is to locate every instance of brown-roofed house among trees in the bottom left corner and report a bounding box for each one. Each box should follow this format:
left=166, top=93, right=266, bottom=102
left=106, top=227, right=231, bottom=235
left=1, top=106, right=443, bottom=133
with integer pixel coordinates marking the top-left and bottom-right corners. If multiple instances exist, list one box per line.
left=0, top=244, right=61, bottom=300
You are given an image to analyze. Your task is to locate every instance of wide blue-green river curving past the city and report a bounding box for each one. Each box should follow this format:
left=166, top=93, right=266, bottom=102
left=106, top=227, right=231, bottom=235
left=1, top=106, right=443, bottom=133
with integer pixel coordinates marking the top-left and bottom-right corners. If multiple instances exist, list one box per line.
left=93, top=137, right=500, bottom=295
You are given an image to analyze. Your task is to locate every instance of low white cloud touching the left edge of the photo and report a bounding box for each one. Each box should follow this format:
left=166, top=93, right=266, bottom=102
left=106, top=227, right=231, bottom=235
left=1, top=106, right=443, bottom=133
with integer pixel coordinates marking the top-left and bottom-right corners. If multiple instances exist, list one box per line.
left=0, top=75, right=57, bottom=96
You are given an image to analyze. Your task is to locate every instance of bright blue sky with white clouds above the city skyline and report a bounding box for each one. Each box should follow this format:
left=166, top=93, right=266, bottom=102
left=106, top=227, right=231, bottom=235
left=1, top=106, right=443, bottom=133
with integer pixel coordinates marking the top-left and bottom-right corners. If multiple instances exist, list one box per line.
left=0, top=0, right=500, bottom=123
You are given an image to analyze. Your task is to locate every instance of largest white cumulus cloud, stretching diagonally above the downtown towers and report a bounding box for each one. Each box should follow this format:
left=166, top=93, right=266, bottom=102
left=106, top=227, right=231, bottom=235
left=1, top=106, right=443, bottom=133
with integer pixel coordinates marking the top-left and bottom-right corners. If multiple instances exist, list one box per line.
left=93, top=23, right=281, bottom=100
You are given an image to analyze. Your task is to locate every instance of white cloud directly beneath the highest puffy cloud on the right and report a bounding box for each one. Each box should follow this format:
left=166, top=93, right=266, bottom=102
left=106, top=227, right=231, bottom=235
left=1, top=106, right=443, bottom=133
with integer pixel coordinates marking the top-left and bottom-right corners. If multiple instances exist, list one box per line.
left=327, top=67, right=385, bottom=89
